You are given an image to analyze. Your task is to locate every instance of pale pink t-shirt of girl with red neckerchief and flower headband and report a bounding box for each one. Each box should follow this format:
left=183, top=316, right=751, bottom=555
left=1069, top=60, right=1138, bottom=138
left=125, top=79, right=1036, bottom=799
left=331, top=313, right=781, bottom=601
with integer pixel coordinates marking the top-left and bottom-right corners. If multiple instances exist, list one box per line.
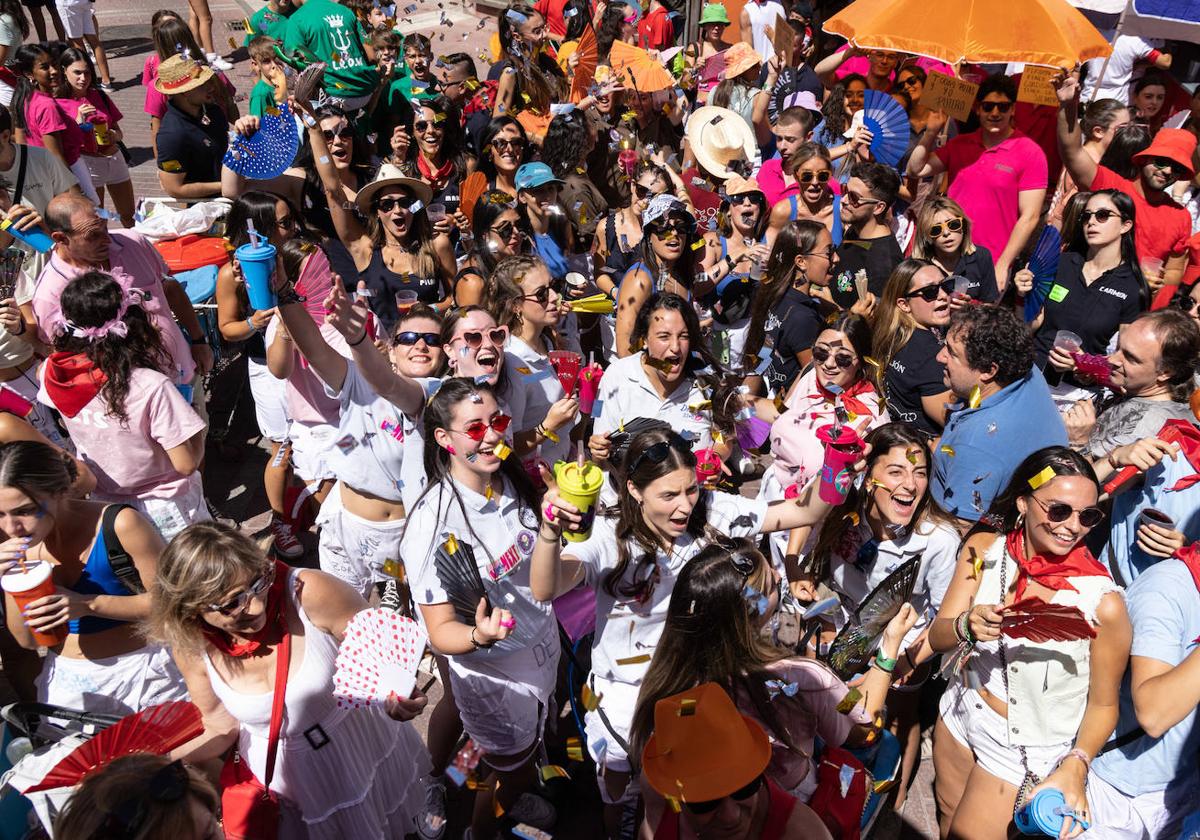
left=37, top=367, right=204, bottom=499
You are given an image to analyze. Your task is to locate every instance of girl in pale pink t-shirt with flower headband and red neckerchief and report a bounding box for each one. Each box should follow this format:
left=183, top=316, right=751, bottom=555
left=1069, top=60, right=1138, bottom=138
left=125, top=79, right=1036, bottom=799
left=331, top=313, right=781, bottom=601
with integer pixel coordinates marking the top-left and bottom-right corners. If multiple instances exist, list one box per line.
left=37, top=271, right=210, bottom=539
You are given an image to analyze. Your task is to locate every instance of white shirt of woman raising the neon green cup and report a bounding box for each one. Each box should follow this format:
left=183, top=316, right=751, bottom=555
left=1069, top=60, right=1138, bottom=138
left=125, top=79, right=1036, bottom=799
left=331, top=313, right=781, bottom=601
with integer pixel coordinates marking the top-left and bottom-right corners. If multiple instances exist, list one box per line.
left=563, top=492, right=768, bottom=685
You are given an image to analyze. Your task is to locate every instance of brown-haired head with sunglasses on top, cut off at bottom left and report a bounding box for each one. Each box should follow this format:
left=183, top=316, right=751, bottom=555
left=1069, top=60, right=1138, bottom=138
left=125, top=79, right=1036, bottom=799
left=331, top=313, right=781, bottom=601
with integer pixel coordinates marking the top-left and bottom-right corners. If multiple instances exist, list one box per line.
left=54, top=752, right=218, bottom=840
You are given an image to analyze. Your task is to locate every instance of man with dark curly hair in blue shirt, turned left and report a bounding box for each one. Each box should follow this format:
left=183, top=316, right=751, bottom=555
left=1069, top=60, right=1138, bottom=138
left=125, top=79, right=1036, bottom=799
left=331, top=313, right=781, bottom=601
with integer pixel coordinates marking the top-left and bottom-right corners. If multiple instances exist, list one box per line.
left=931, top=306, right=1067, bottom=522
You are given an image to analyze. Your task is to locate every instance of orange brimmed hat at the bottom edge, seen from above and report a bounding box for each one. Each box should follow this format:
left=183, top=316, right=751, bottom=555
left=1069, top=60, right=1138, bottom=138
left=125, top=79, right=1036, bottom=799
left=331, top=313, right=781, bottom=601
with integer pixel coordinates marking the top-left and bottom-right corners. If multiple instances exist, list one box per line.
left=642, top=683, right=770, bottom=802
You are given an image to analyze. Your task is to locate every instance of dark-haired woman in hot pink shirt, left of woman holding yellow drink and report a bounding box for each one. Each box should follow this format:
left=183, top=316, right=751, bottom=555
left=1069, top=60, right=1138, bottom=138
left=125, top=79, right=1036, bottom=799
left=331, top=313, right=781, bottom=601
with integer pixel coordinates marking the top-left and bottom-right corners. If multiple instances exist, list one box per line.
left=10, top=43, right=100, bottom=204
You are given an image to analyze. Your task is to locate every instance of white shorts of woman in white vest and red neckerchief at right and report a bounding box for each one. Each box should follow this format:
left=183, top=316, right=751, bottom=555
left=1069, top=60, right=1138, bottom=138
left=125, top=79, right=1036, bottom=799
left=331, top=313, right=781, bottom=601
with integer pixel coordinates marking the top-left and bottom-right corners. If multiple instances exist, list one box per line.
left=940, top=682, right=1072, bottom=787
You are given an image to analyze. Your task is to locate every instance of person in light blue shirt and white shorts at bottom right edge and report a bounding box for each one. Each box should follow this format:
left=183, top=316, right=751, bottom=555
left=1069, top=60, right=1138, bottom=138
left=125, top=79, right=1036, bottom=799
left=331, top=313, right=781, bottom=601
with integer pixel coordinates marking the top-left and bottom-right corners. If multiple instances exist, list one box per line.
left=1087, top=544, right=1200, bottom=840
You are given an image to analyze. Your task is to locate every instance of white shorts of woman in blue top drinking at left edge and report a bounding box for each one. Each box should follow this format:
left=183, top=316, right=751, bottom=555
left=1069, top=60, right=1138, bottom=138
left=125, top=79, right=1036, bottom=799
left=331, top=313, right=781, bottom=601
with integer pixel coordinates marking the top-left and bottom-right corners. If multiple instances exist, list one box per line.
left=35, top=644, right=187, bottom=715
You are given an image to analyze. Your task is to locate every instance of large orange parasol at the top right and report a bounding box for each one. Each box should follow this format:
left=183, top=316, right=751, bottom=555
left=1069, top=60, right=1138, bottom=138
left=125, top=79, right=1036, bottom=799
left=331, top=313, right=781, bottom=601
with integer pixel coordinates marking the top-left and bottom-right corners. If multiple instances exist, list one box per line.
left=824, top=0, right=1112, bottom=67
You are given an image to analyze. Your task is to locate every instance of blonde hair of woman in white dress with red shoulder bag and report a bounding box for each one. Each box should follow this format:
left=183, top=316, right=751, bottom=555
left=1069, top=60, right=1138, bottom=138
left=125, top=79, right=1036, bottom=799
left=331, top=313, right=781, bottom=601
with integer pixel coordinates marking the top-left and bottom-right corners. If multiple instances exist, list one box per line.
left=144, top=522, right=269, bottom=653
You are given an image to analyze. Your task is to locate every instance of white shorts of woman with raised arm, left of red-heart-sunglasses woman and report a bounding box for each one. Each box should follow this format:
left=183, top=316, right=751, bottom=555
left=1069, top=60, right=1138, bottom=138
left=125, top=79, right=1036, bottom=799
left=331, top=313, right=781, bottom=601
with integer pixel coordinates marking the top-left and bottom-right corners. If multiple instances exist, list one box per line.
left=317, top=481, right=404, bottom=598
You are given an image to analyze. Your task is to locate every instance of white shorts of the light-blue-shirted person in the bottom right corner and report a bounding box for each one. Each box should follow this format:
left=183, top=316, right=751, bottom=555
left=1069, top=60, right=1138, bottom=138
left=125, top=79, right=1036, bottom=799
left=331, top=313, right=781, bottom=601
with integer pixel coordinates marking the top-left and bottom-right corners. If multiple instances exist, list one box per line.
left=1082, top=773, right=1200, bottom=840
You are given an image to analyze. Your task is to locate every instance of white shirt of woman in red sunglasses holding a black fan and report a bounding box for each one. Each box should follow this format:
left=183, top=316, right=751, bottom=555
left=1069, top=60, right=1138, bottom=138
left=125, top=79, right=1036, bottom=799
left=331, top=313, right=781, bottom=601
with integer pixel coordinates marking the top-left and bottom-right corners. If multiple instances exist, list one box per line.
left=400, top=478, right=558, bottom=701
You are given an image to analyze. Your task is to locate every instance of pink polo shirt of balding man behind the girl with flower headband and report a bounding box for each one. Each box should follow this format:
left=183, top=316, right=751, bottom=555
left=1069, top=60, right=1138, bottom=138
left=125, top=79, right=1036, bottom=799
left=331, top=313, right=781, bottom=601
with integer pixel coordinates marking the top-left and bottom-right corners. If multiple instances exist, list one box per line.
left=34, top=230, right=196, bottom=385
